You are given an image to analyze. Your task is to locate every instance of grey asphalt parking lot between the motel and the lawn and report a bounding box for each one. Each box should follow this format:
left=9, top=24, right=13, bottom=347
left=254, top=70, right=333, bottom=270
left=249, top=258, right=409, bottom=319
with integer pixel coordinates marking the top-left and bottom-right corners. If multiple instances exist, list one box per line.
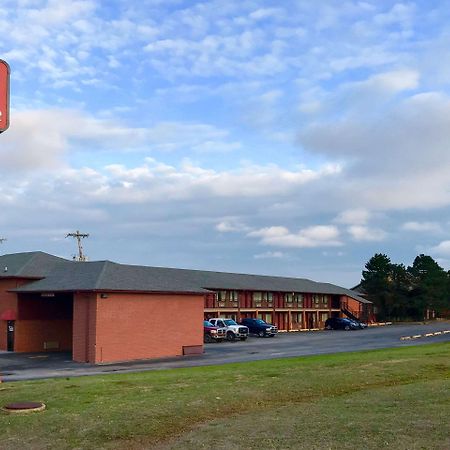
left=0, top=322, right=450, bottom=381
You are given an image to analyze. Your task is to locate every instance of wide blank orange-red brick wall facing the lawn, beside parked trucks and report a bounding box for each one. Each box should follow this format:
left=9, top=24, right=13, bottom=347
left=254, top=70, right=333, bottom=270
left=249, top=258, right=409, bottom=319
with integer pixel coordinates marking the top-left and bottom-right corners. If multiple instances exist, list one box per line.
left=90, top=293, right=204, bottom=363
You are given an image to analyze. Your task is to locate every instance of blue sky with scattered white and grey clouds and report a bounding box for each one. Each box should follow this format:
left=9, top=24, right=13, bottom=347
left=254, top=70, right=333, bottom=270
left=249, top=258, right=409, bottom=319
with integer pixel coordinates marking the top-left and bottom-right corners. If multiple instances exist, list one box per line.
left=0, top=0, right=450, bottom=287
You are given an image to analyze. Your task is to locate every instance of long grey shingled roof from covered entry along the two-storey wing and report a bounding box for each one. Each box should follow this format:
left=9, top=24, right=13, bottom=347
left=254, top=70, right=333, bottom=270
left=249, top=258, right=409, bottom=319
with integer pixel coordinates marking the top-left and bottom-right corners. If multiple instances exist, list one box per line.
left=7, top=250, right=370, bottom=303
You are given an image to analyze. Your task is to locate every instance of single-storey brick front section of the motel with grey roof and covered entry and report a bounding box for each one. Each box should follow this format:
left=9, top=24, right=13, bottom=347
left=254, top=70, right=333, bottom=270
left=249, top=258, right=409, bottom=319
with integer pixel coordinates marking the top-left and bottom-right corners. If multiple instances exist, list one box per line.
left=0, top=252, right=207, bottom=363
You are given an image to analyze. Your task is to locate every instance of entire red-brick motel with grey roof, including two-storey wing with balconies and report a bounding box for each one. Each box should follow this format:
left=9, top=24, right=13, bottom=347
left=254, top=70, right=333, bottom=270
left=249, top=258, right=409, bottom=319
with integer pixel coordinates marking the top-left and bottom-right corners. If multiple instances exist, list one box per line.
left=0, top=252, right=373, bottom=364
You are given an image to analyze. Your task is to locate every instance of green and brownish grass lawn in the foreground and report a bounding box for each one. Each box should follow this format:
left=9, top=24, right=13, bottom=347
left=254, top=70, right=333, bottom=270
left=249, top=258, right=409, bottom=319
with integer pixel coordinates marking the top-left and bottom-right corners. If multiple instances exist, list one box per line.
left=0, top=343, right=450, bottom=450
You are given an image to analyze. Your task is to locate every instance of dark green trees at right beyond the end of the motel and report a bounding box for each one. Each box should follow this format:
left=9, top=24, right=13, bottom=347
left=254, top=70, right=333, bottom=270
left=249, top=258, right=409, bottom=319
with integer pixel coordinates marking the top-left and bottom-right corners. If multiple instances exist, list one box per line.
left=360, top=253, right=450, bottom=321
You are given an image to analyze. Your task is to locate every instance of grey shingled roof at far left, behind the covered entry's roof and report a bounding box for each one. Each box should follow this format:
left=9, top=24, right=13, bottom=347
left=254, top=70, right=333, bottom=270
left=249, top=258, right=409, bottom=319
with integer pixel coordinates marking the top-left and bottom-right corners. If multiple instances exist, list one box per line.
left=0, top=252, right=68, bottom=278
